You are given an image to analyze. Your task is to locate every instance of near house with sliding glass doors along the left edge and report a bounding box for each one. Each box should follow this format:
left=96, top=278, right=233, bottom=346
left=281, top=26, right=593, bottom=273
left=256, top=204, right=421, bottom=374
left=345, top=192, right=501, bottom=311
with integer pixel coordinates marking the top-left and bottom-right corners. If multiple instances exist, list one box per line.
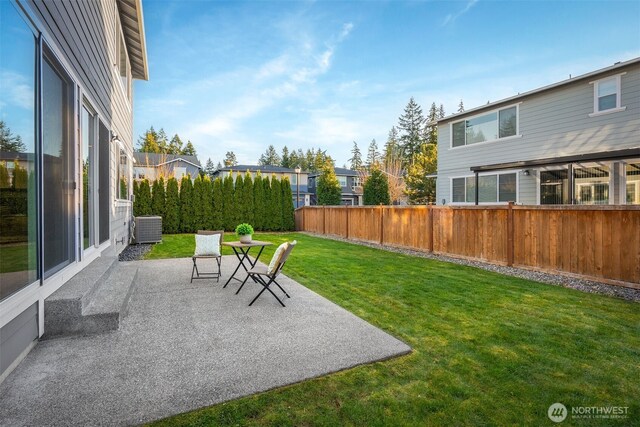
left=0, top=0, right=148, bottom=381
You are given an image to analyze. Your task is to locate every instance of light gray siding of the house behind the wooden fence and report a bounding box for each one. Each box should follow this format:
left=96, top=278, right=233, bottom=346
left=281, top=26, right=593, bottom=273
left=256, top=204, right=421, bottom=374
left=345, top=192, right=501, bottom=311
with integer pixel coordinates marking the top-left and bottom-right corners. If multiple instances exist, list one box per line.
left=437, top=64, right=640, bottom=204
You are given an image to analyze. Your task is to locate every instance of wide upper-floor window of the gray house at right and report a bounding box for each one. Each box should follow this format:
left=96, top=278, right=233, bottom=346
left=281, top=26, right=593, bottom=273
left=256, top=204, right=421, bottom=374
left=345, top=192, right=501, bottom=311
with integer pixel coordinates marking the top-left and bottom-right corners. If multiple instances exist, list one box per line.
left=451, top=105, right=518, bottom=147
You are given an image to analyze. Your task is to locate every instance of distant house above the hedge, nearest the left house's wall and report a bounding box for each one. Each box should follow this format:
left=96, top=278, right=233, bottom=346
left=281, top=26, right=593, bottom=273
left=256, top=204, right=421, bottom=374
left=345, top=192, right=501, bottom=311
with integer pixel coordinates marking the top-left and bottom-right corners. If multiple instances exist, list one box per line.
left=133, top=151, right=202, bottom=182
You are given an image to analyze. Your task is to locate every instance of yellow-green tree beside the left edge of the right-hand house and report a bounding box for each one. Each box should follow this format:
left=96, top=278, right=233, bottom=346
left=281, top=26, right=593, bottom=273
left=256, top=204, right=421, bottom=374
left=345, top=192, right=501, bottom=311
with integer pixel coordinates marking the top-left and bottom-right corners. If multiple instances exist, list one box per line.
left=405, top=144, right=438, bottom=205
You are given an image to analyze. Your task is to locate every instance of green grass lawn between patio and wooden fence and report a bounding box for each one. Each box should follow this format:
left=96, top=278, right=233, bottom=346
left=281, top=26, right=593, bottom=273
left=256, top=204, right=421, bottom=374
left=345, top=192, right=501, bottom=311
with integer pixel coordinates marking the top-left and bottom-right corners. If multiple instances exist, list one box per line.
left=148, top=233, right=640, bottom=426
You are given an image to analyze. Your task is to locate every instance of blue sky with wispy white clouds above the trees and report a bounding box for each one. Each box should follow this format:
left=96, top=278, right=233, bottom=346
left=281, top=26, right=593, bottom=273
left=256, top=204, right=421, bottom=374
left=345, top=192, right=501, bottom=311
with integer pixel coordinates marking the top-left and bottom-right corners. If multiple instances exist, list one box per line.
left=134, top=0, right=640, bottom=166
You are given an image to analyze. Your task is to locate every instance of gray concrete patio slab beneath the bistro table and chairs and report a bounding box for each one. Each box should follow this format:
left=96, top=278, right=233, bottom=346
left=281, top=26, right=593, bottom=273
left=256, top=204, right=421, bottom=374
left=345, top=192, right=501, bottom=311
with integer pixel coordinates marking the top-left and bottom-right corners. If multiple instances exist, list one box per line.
left=0, top=257, right=411, bottom=426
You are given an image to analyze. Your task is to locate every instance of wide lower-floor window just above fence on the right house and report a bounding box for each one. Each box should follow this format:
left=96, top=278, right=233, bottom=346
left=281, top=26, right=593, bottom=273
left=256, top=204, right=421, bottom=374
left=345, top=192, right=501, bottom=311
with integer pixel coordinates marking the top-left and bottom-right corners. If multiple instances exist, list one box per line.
left=451, top=173, right=517, bottom=203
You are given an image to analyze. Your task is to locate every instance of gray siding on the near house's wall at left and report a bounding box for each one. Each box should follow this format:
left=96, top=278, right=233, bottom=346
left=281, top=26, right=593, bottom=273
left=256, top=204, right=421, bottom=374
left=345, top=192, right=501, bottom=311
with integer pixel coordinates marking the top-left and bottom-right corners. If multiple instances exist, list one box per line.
left=25, top=0, right=133, bottom=251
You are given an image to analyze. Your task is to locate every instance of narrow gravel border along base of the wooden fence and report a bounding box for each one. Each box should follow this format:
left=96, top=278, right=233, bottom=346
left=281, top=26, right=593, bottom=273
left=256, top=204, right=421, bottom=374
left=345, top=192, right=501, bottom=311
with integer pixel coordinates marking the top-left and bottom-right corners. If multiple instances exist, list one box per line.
left=302, top=232, right=640, bottom=302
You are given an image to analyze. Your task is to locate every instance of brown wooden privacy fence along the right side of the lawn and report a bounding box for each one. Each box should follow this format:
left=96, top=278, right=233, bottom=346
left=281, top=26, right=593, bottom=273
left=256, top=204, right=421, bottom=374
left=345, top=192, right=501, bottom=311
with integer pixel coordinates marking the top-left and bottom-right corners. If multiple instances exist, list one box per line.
left=296, top=204, right=640, bottom=289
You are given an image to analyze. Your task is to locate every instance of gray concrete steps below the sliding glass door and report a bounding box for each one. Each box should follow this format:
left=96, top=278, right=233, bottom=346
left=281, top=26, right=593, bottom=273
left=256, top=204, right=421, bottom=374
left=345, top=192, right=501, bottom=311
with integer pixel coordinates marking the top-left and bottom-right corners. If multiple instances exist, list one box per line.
left=43, top=257, right=138, bottom=339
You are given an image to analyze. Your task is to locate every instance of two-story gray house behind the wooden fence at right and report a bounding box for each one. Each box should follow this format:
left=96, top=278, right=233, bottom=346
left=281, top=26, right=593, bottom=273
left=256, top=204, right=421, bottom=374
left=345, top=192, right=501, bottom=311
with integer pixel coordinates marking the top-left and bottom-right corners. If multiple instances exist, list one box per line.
left=437, top=58, right=640, bottom=205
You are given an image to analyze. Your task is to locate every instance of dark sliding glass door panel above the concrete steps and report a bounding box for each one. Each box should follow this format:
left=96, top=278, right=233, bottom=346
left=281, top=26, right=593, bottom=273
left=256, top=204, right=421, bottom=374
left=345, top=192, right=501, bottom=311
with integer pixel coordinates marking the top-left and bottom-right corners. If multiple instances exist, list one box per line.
left=42, top=51, right=76, bottom=277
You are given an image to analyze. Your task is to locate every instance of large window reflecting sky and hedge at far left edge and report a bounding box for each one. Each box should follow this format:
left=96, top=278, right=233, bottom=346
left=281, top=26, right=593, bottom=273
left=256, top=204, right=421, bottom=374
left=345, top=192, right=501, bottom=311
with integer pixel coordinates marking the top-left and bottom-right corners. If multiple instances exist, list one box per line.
left=0, top=1, right=39, bottom=300
